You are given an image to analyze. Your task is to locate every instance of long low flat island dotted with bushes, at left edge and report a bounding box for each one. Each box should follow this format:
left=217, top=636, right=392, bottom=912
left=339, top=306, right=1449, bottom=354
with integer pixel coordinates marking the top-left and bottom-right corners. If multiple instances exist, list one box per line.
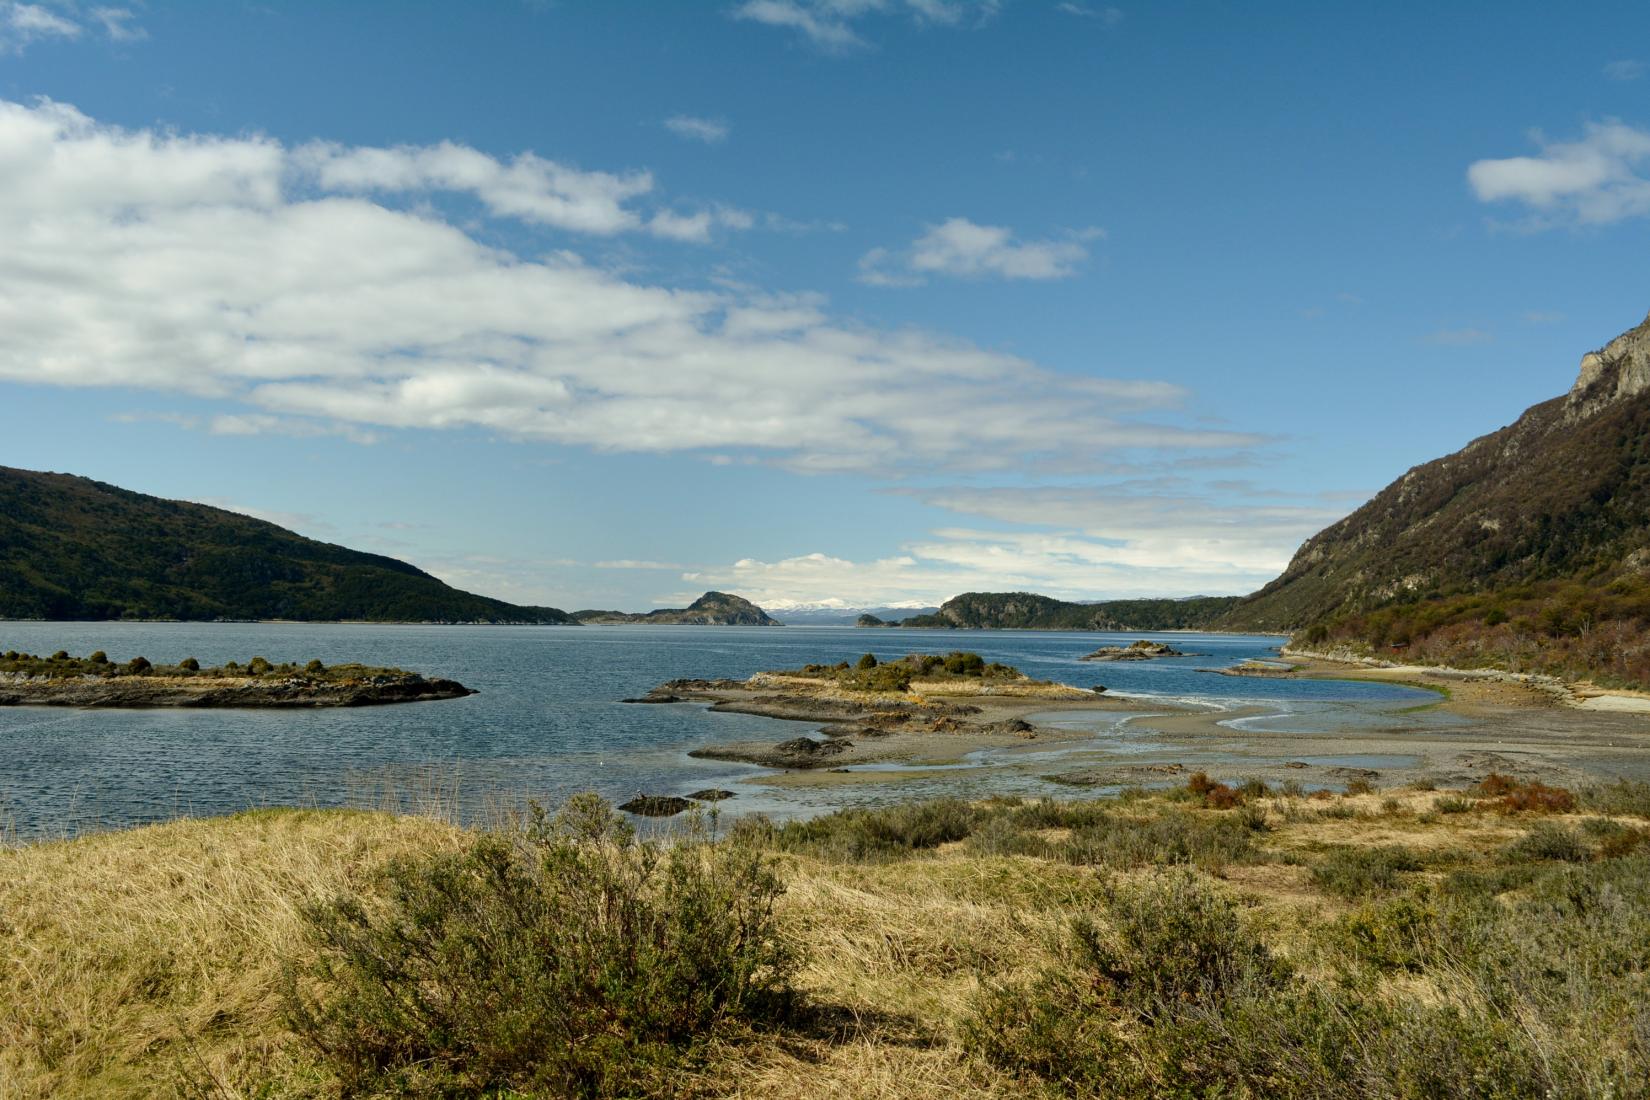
left=0, top=650, right=475, bottom=707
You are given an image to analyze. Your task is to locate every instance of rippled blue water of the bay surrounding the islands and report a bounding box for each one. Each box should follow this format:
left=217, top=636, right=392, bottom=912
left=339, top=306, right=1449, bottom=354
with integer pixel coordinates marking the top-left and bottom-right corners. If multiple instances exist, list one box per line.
left=0, top=623, right=1436, bottom=838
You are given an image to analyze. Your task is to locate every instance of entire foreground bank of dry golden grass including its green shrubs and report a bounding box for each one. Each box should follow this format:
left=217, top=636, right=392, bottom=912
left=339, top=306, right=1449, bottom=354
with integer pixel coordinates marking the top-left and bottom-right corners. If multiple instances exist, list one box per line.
left=0, top=777, right=1650, bottom=1098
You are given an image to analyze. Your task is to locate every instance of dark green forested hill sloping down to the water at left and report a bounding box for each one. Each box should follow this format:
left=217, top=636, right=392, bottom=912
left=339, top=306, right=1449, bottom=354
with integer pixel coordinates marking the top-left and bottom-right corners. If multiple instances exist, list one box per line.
left=0, top=467, right=573, bottom=623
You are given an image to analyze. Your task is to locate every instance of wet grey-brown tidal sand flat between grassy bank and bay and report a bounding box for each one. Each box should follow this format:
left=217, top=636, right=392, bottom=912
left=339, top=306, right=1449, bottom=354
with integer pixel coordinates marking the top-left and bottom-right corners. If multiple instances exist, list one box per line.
left=653, top=660, right=1650, bottom=790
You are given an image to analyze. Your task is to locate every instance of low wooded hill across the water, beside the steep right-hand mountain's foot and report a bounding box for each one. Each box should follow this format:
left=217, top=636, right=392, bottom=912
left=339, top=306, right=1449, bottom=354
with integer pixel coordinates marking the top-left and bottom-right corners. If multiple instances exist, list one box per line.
left=891, top=592, right=1239, bottom=630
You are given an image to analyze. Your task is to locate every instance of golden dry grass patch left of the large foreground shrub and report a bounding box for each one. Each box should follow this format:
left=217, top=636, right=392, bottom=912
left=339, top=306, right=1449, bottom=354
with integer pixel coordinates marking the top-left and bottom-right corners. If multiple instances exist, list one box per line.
left=0, top=810, right=460, bottom=1100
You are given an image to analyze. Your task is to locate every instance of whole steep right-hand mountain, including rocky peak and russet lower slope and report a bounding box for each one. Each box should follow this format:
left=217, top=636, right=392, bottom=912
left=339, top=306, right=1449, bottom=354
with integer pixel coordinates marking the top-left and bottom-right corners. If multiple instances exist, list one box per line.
left=1221, top=310, right=1650, bottom=684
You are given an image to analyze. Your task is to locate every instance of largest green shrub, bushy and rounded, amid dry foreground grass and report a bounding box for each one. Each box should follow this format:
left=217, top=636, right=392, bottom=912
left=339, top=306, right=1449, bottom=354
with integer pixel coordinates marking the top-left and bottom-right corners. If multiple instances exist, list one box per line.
left=285, top=797, right=792, bottom=1097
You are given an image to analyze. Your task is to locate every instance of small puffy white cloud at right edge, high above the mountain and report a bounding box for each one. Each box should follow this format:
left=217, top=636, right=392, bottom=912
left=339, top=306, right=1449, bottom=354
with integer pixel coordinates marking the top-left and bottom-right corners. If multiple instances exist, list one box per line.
left=1467, top=122, right=1650, bottom=228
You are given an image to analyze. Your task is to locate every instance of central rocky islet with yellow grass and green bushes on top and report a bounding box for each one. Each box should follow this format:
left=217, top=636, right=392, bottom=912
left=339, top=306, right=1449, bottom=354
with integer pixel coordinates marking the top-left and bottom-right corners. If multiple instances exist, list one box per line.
left=625, top=651, right=1125, bottom=772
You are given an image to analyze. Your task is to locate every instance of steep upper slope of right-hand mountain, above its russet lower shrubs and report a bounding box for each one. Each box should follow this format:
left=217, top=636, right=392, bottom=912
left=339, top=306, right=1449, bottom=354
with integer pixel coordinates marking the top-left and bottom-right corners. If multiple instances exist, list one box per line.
left=1221, top=310, right=1650, bottom=630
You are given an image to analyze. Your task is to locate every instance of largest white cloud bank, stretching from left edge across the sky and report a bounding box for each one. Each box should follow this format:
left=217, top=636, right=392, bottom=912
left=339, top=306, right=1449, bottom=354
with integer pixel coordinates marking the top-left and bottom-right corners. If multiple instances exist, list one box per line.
left=0, top=101, right=1261, bottom=477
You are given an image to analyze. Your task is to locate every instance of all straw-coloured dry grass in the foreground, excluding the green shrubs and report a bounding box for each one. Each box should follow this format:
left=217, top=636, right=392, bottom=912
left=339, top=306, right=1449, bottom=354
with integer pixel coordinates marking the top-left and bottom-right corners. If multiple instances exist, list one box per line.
left=0, top=792, right=1630, bottom=1100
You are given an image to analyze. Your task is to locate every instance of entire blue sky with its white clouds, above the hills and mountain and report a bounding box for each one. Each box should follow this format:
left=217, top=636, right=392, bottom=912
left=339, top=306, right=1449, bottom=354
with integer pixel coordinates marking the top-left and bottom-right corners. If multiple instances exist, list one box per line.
left=0, top=0, right=1650, bottom=609
